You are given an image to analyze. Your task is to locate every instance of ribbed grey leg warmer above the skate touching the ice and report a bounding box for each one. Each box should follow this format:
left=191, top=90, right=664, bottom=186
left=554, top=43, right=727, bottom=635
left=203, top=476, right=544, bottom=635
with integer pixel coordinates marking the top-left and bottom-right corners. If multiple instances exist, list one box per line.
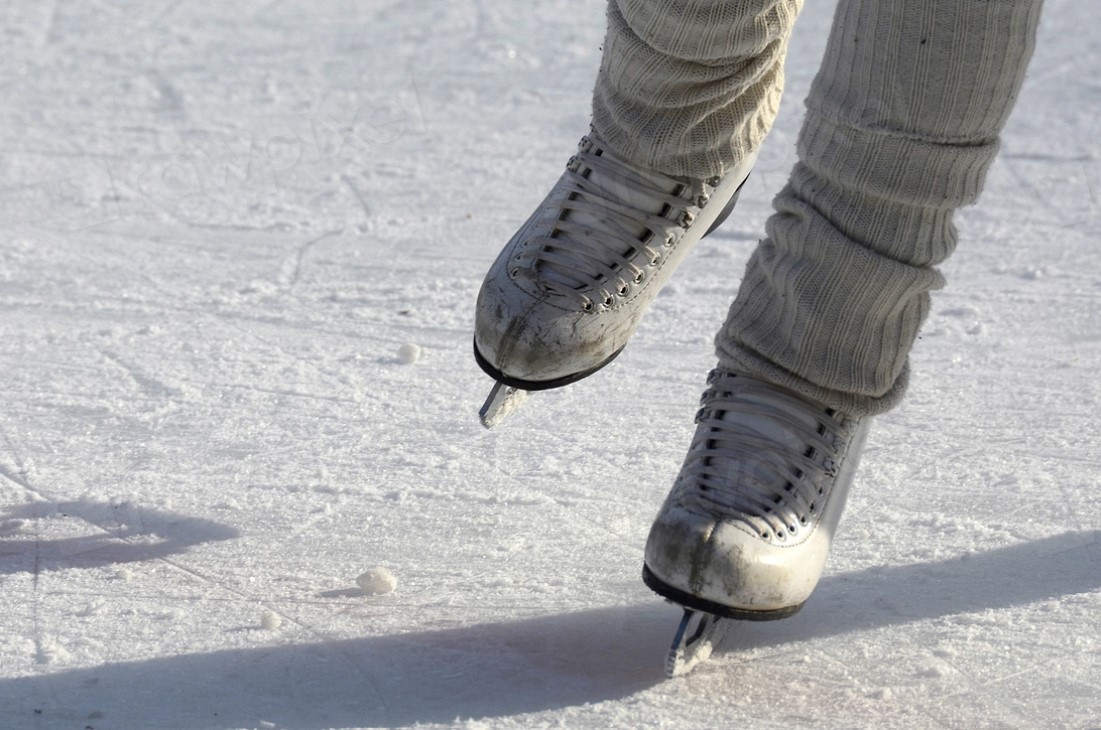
left=717, top=0, right=1042, bottom=415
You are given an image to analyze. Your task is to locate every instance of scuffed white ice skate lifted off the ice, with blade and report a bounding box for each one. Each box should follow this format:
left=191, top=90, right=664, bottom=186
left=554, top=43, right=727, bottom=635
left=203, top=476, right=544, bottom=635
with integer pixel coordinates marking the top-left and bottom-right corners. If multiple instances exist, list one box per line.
left=475, top=135, right=754, bottom=426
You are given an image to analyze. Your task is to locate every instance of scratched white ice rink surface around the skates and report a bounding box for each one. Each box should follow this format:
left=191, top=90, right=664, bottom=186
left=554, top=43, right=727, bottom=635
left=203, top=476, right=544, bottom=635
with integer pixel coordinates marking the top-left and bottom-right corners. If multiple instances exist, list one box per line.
left=0, top=0, right=1101, bottom=730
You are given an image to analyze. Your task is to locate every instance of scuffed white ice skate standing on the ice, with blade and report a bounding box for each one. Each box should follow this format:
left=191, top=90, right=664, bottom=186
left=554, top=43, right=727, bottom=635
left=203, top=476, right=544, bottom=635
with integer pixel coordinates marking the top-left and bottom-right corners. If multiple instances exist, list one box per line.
left=643, top=370, right=871, bottom=674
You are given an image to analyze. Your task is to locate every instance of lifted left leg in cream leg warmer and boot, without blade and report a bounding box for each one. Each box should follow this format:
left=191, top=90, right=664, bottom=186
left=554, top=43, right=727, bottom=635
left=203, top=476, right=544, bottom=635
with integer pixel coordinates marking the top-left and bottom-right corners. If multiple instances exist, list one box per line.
left=475, top=0, right=800, bottom=400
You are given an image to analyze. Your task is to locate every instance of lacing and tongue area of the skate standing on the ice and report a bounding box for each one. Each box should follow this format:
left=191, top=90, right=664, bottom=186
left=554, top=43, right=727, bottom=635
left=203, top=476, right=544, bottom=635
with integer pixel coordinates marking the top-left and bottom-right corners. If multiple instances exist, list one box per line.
left=678, top=370, right=854, bottom=543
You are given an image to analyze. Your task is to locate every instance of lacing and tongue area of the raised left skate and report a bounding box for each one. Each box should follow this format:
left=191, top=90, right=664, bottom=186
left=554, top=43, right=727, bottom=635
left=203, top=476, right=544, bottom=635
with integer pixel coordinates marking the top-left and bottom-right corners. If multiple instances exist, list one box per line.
left=512, top=138, right=718, bottom=312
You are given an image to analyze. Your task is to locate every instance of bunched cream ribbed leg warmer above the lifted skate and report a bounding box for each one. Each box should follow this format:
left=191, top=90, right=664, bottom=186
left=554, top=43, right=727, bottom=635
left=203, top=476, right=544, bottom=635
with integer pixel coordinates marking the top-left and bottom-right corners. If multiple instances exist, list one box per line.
left=592, top=0, right=803, bottom=178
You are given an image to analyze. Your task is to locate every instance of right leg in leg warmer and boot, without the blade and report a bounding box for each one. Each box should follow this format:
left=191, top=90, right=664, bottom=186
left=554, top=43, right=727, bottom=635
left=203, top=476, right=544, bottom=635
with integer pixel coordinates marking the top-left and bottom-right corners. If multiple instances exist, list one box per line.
left=646, top=0, right=1040, bottom=618
